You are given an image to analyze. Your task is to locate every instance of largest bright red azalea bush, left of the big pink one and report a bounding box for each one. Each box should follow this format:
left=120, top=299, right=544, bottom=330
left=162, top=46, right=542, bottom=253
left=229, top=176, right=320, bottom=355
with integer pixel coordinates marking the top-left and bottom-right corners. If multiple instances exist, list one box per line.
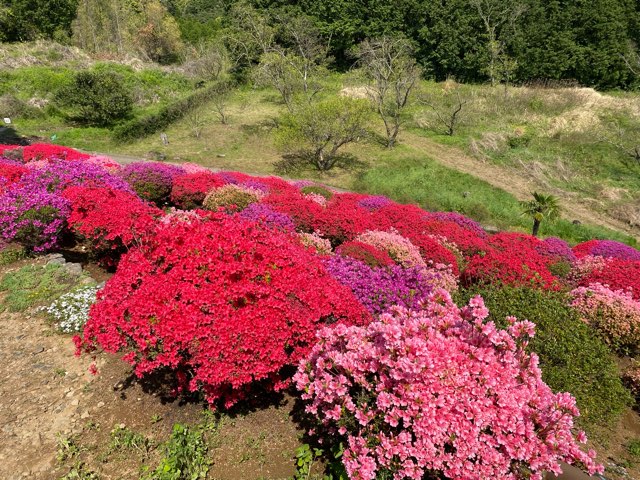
left=77, top=218, right=369, bottom=406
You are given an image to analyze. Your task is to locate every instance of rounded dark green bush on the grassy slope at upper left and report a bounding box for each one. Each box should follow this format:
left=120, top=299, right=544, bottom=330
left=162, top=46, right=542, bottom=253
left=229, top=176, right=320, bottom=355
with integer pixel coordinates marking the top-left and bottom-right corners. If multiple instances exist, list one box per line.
left=55, top=71, right=133, bottom=126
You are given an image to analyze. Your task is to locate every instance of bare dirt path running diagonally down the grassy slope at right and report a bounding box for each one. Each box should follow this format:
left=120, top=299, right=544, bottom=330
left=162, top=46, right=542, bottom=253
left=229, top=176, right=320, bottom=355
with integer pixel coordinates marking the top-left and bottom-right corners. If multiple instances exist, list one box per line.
left=402, top=132, right=640, bottom=241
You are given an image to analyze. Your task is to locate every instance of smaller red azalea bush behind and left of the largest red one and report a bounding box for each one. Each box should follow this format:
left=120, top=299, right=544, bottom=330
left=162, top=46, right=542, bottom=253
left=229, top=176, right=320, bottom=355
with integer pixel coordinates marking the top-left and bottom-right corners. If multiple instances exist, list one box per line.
left=62, top=187, right=162, bottom=263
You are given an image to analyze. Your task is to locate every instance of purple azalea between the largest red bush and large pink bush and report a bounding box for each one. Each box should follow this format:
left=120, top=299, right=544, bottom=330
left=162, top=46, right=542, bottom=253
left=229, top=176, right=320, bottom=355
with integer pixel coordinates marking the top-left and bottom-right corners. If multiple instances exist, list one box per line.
left=324, top=255, right=434, bottom=315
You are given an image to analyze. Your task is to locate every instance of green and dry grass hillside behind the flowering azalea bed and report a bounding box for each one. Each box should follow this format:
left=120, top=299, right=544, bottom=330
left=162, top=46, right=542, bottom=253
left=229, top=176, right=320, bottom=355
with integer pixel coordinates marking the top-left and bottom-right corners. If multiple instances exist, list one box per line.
left=8, top=65, right=640, bottom=244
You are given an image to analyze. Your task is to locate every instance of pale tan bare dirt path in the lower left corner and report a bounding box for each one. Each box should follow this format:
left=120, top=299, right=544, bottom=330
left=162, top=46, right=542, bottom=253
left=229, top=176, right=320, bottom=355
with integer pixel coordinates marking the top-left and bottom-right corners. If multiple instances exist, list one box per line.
left=0, top=294, right=93, bottom=480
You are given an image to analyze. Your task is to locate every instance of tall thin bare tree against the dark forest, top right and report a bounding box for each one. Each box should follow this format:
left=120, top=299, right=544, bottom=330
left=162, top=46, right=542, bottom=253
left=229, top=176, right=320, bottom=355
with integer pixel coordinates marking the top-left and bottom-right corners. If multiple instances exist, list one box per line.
left=469, top=0, right=526, bottom=86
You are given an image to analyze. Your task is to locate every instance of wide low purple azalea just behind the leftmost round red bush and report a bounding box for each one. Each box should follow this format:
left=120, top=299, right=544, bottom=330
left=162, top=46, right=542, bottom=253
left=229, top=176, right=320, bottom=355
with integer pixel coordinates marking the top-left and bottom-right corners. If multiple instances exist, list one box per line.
left=22, top=158, right=133, bottom=193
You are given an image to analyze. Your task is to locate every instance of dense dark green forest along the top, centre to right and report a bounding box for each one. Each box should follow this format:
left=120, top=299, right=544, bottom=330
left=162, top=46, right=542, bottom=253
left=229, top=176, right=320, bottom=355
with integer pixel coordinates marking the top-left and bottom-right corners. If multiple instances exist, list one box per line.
left=272, top=0, right=640, bottom=88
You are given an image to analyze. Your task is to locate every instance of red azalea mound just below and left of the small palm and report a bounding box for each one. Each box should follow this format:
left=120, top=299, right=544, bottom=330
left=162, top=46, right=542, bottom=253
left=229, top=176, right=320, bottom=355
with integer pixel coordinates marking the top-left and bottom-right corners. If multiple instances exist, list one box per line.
left=461, top=249, right=561, bottom=290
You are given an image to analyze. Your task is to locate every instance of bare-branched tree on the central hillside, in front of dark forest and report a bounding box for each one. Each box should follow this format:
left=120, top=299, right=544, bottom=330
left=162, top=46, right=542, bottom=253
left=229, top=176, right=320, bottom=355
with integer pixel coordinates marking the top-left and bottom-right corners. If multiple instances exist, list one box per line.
left=354, top=37, right=420, bottom=148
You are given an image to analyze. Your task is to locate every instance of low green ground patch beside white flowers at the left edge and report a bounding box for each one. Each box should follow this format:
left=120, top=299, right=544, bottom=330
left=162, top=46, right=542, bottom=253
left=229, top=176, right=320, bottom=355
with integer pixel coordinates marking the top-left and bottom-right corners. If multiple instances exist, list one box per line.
left=0, top=264, right=84, bottom=312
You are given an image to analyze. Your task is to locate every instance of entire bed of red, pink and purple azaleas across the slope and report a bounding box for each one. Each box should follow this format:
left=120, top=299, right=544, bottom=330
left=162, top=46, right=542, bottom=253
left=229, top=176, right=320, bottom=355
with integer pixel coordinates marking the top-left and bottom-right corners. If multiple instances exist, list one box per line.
left=0, top=142, right=640, bottom=479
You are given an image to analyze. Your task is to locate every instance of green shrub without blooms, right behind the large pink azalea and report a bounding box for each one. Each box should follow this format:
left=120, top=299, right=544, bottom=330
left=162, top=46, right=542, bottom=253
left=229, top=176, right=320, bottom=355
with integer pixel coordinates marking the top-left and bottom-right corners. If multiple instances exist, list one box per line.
left=460, top=286, right=631, bottom=430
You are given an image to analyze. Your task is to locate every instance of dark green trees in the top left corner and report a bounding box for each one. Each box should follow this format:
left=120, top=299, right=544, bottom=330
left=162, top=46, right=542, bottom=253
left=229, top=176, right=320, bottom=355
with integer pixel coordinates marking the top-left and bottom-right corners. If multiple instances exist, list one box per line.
left=0, top=0, right=78, bottom=42
